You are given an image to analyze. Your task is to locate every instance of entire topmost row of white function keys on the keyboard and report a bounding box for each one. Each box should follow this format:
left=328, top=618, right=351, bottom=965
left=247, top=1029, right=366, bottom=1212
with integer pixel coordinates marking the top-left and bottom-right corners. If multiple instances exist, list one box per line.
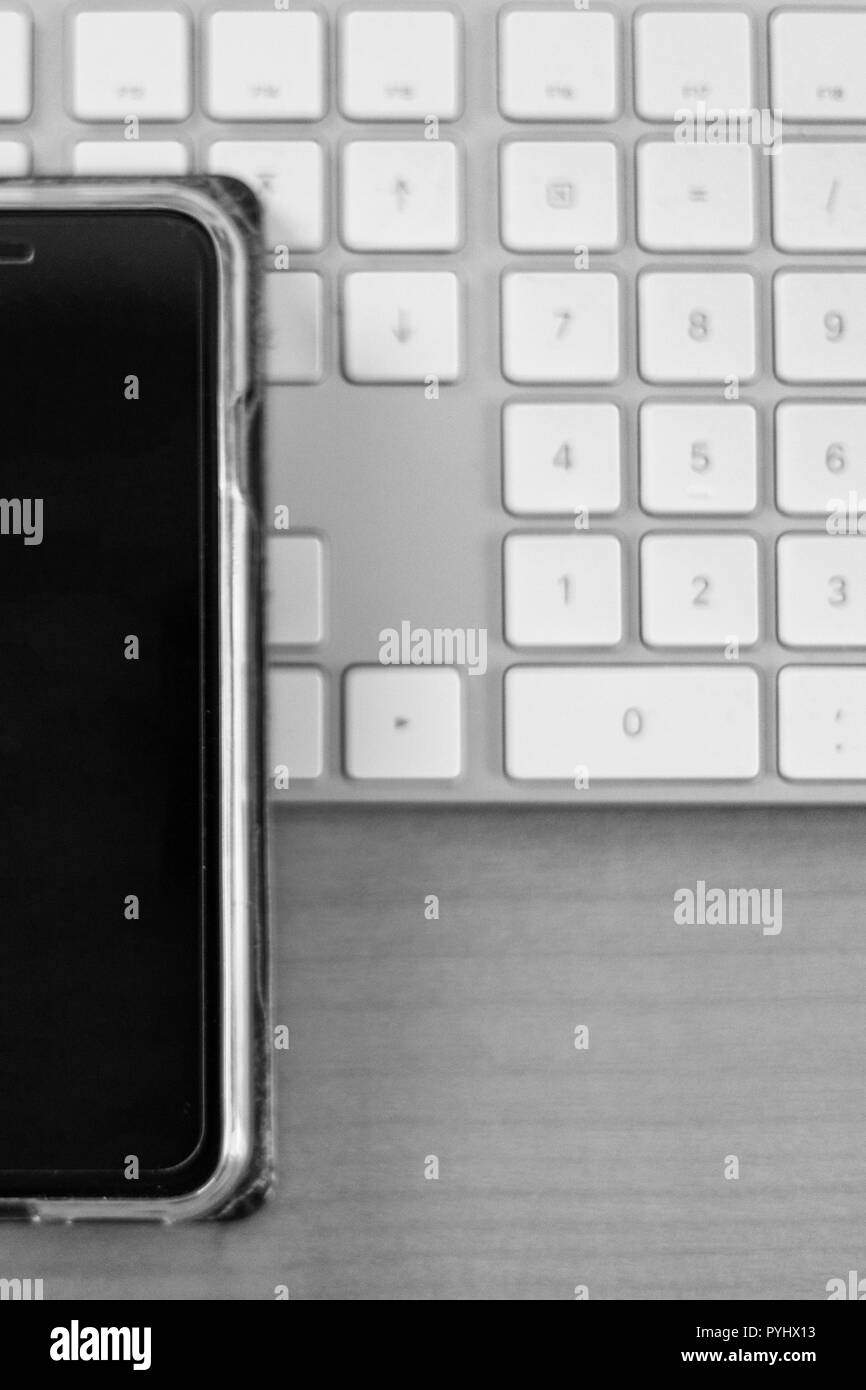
left=0, top=6, right=866, bottom=121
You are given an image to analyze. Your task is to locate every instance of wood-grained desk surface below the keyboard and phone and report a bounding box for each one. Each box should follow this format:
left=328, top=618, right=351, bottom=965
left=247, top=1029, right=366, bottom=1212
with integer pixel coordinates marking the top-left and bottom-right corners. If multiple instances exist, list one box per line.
left=0, top=809, right=866, bottom=1300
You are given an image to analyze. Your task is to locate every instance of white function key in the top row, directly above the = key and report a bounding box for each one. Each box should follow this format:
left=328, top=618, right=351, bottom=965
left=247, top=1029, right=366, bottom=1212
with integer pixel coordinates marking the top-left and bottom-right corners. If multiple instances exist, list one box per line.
left=635, top=10, right=753, bottom=121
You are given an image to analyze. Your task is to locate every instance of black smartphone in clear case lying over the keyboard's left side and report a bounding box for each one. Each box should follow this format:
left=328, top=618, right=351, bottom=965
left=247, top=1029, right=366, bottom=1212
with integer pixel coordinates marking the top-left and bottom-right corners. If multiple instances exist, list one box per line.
left=0, top=179, right=268, bottom=1220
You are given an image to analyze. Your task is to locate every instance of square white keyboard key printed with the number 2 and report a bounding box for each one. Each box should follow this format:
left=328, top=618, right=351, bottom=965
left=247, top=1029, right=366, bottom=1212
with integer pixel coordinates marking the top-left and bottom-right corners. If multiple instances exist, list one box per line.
left=641, top=534, right=758, bottom=648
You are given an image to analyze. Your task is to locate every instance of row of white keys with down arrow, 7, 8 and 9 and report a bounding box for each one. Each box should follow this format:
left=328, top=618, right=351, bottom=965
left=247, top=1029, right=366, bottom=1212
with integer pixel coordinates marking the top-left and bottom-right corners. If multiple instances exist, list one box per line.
left=265, top=270, right=866, bottom=386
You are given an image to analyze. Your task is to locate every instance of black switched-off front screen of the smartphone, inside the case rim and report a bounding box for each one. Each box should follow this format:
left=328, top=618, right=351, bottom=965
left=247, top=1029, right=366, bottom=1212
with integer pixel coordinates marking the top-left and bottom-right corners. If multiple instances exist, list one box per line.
left=0, top=210, right=220, bottom=1198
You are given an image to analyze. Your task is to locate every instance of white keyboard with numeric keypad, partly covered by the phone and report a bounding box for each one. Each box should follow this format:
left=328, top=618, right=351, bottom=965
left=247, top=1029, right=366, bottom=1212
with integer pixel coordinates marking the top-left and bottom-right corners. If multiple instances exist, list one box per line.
left=8, top=0, right=866, bottom=805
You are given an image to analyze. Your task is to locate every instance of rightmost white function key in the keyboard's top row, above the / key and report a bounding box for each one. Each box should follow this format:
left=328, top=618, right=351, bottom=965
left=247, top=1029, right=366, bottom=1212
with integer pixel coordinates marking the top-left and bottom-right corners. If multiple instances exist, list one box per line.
left=770, top=7, right=866, bottom=121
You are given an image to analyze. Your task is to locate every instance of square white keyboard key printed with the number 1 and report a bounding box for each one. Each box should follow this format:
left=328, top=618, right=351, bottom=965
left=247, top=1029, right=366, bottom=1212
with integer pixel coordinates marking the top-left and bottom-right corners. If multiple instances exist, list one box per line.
left=503, top=535, right=623, bottom=646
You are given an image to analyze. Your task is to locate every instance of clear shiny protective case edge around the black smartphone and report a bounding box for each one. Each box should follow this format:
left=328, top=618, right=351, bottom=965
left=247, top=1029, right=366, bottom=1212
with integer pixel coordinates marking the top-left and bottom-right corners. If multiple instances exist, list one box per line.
left=0, top=177, right=272, bottom=1222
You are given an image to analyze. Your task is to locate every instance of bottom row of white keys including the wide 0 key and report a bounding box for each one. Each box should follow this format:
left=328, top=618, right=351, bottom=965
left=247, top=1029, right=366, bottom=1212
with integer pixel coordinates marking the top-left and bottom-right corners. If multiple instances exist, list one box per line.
left=268, top=666, right=866, bottom=794
